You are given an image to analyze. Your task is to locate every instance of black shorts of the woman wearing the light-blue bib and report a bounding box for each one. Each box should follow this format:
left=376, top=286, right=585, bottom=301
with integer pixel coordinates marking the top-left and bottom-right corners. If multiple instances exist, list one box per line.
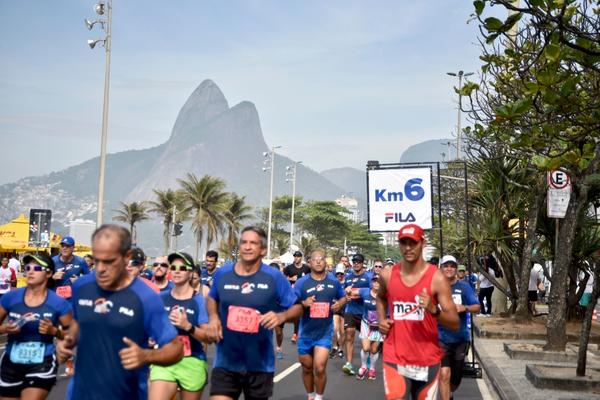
left=0, top=352, right=58, bottom=397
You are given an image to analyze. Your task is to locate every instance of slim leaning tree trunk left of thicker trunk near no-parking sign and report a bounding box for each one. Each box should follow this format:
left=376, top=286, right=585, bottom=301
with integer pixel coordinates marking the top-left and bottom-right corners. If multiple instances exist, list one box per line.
left=515, top=186, right=546, bottom=323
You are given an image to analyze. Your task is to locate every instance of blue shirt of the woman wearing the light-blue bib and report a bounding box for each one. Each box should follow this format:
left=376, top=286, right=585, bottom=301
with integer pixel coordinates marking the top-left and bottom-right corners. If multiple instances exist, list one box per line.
left=0, top=287, right=73, bottom=356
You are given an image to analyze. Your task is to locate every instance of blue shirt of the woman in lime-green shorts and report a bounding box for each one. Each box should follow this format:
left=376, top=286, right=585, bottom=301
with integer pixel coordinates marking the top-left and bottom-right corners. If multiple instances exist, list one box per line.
left=160, top=293, right=208, bottom=360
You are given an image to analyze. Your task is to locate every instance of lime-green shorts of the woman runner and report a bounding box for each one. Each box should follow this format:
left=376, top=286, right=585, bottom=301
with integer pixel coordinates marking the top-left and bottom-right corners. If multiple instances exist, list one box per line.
left=150, top=356, right=207, bottom=392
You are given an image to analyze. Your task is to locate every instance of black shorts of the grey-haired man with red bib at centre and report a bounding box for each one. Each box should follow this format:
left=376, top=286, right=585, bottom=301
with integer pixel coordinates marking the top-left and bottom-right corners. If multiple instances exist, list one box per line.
left=210, top=368, right=274, bottom=400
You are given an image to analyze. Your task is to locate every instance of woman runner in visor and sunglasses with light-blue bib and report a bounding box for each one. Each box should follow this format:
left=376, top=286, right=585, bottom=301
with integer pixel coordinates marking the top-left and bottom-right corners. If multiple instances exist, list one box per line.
left=0, top=253, right=73, bottom=399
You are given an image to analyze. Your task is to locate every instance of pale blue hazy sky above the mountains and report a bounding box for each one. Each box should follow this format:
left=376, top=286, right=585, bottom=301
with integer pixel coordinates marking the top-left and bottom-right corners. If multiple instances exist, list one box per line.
left=0, top=0, right=488, bottom=183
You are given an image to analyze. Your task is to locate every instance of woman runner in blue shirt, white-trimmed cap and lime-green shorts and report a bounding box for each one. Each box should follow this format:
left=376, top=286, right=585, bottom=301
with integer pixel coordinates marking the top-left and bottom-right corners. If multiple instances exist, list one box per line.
left=149, top=252, right=213, bottom=400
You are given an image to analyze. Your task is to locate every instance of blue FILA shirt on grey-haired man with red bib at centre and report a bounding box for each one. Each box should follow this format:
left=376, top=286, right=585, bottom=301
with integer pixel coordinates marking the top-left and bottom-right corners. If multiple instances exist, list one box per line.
left=209, top=264, right=296, bottom=372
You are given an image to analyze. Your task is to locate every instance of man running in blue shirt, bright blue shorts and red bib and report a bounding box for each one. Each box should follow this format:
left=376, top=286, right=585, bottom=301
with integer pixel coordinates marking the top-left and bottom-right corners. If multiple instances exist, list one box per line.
left=294, top=250, right=346, bottom=400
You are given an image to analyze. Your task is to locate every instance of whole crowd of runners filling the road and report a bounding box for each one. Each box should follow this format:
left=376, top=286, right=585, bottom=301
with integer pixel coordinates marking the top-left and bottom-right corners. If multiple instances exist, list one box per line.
left=0, top=224, right=480, bottom=400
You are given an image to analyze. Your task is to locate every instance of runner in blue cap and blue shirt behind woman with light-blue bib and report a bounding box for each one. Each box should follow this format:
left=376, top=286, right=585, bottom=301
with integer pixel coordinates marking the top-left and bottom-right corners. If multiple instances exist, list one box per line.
left=52, top=236, right=90, bottom=299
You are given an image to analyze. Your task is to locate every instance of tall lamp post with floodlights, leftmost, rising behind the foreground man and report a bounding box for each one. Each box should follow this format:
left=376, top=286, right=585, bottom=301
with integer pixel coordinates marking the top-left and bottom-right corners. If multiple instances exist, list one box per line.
left=85, top=0, right=112, bottom=226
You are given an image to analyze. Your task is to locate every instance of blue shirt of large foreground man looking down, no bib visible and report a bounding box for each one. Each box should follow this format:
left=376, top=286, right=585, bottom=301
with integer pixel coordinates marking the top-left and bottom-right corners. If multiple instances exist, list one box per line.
left=67, top=274, right=177, bottom=400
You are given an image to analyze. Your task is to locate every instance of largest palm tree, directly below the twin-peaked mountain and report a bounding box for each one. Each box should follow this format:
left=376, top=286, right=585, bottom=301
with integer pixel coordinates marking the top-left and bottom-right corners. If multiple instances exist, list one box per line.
left=177, top=173, right=229, bottom=258
